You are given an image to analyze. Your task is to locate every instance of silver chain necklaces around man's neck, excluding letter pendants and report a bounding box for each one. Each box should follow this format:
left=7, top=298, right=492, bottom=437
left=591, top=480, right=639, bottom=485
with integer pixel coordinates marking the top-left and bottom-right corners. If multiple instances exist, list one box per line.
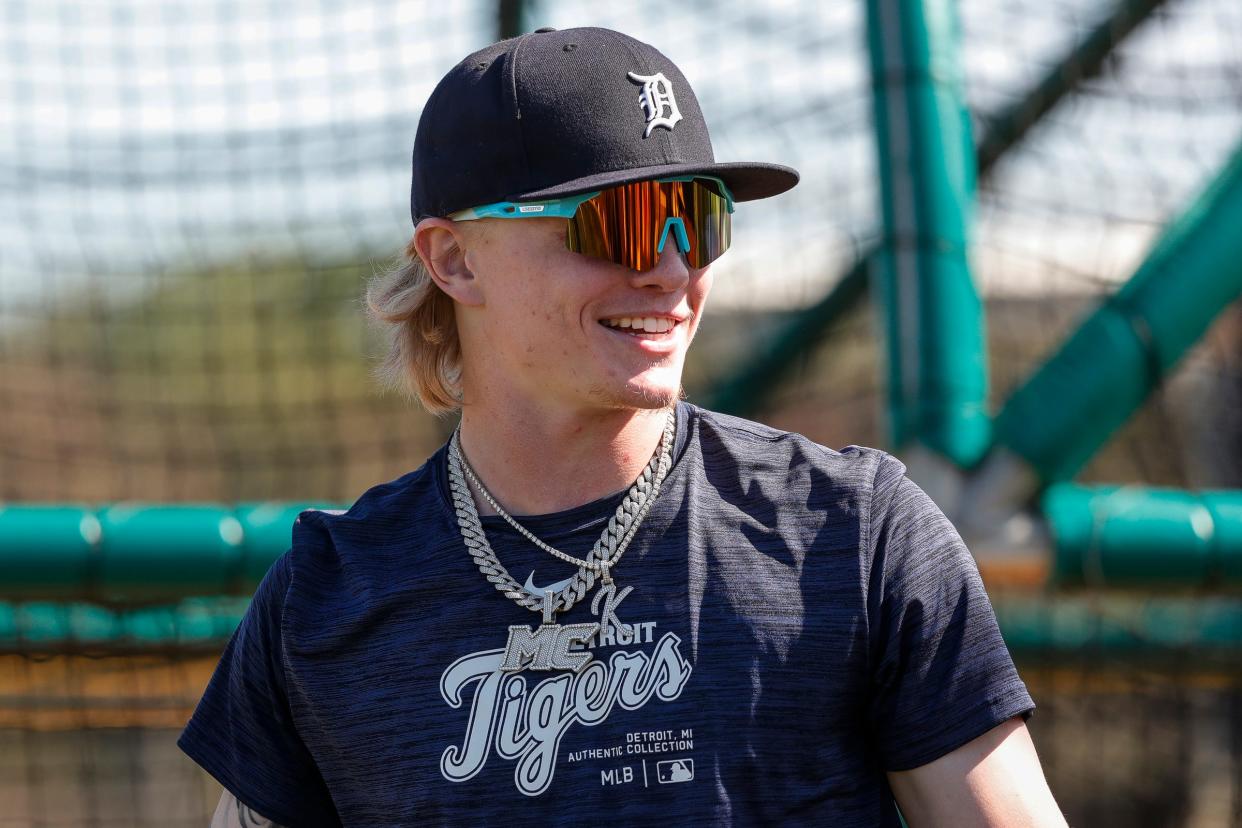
left=448, top=408, right=676, bottom=624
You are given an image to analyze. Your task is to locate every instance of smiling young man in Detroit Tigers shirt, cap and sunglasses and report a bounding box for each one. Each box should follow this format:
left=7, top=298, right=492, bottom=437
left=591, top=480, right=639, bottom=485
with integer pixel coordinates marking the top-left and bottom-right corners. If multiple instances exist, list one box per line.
left=179, top=29, right=1064, bottom=827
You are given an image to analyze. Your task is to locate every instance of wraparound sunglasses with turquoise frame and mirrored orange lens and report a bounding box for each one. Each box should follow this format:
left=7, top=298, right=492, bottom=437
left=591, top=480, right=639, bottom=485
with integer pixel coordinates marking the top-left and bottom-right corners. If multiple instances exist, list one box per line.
left=448, top=176, right=733, bottom=272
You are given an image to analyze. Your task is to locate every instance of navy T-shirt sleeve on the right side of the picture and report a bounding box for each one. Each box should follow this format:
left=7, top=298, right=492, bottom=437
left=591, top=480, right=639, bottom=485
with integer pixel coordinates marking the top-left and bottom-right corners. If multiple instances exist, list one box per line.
left=867, top=454, right=1035, bottom=771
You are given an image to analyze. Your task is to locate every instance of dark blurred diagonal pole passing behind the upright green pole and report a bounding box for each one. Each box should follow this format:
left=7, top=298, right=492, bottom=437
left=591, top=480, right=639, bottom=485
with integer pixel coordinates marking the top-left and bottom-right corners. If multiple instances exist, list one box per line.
left=703, top=0, right=1161, bottom=416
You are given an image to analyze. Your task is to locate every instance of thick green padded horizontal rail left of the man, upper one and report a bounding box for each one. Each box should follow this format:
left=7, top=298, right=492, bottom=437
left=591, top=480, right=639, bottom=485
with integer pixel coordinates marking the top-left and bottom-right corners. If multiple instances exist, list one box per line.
left=0, top=503, right=345, bottom=605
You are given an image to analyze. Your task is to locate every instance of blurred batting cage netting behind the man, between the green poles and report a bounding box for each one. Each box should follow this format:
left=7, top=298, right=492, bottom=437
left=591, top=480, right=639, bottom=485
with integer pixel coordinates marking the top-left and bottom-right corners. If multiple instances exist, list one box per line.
left=0, top=0, right=1242, bottom=828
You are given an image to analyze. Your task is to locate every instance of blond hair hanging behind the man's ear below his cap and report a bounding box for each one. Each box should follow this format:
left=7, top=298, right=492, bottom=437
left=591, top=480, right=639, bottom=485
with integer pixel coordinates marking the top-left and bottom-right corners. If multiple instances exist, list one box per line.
left=366, top=240, right=462, bottom=416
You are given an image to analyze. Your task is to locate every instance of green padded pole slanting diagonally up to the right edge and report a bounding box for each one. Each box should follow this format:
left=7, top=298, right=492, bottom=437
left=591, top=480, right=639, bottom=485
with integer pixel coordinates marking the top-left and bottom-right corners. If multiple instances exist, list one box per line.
left=995, top=145, right=1242, bottom=482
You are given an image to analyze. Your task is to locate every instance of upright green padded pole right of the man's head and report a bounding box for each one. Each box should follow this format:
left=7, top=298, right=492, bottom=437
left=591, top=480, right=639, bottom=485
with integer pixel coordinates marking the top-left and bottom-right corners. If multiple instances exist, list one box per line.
left=867, top=0, right=991, bottom=467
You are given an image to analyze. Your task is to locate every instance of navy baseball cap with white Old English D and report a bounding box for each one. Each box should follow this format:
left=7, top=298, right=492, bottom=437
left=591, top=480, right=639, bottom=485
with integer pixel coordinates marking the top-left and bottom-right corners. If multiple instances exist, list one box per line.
left=410, top=29, right=799, bottom=223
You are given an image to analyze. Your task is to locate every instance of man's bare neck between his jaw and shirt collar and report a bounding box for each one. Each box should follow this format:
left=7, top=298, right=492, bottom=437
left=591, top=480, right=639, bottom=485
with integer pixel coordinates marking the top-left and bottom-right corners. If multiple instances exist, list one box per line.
left=461, top=405, right=668, bottom=516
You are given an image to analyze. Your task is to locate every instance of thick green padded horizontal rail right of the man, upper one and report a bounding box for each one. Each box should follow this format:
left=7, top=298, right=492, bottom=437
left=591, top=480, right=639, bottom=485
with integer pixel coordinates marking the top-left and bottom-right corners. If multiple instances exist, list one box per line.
left=1042, top=483, right=1242, bottom=588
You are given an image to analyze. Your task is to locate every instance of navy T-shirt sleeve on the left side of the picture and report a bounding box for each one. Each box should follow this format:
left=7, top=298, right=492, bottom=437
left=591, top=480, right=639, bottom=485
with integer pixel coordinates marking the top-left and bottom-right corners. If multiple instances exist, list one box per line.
left=176, top=552, right=340, bottom=827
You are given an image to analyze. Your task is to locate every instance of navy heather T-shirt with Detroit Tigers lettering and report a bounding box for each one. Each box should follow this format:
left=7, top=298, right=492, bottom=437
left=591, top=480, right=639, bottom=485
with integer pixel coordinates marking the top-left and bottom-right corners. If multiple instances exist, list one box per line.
left=178, top=403, right=1035, bottom=828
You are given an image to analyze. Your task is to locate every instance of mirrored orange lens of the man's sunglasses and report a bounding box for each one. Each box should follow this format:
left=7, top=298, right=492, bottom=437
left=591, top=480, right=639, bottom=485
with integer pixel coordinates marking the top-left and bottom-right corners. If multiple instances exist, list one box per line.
left=565, top=180, right=732, bottom=271
